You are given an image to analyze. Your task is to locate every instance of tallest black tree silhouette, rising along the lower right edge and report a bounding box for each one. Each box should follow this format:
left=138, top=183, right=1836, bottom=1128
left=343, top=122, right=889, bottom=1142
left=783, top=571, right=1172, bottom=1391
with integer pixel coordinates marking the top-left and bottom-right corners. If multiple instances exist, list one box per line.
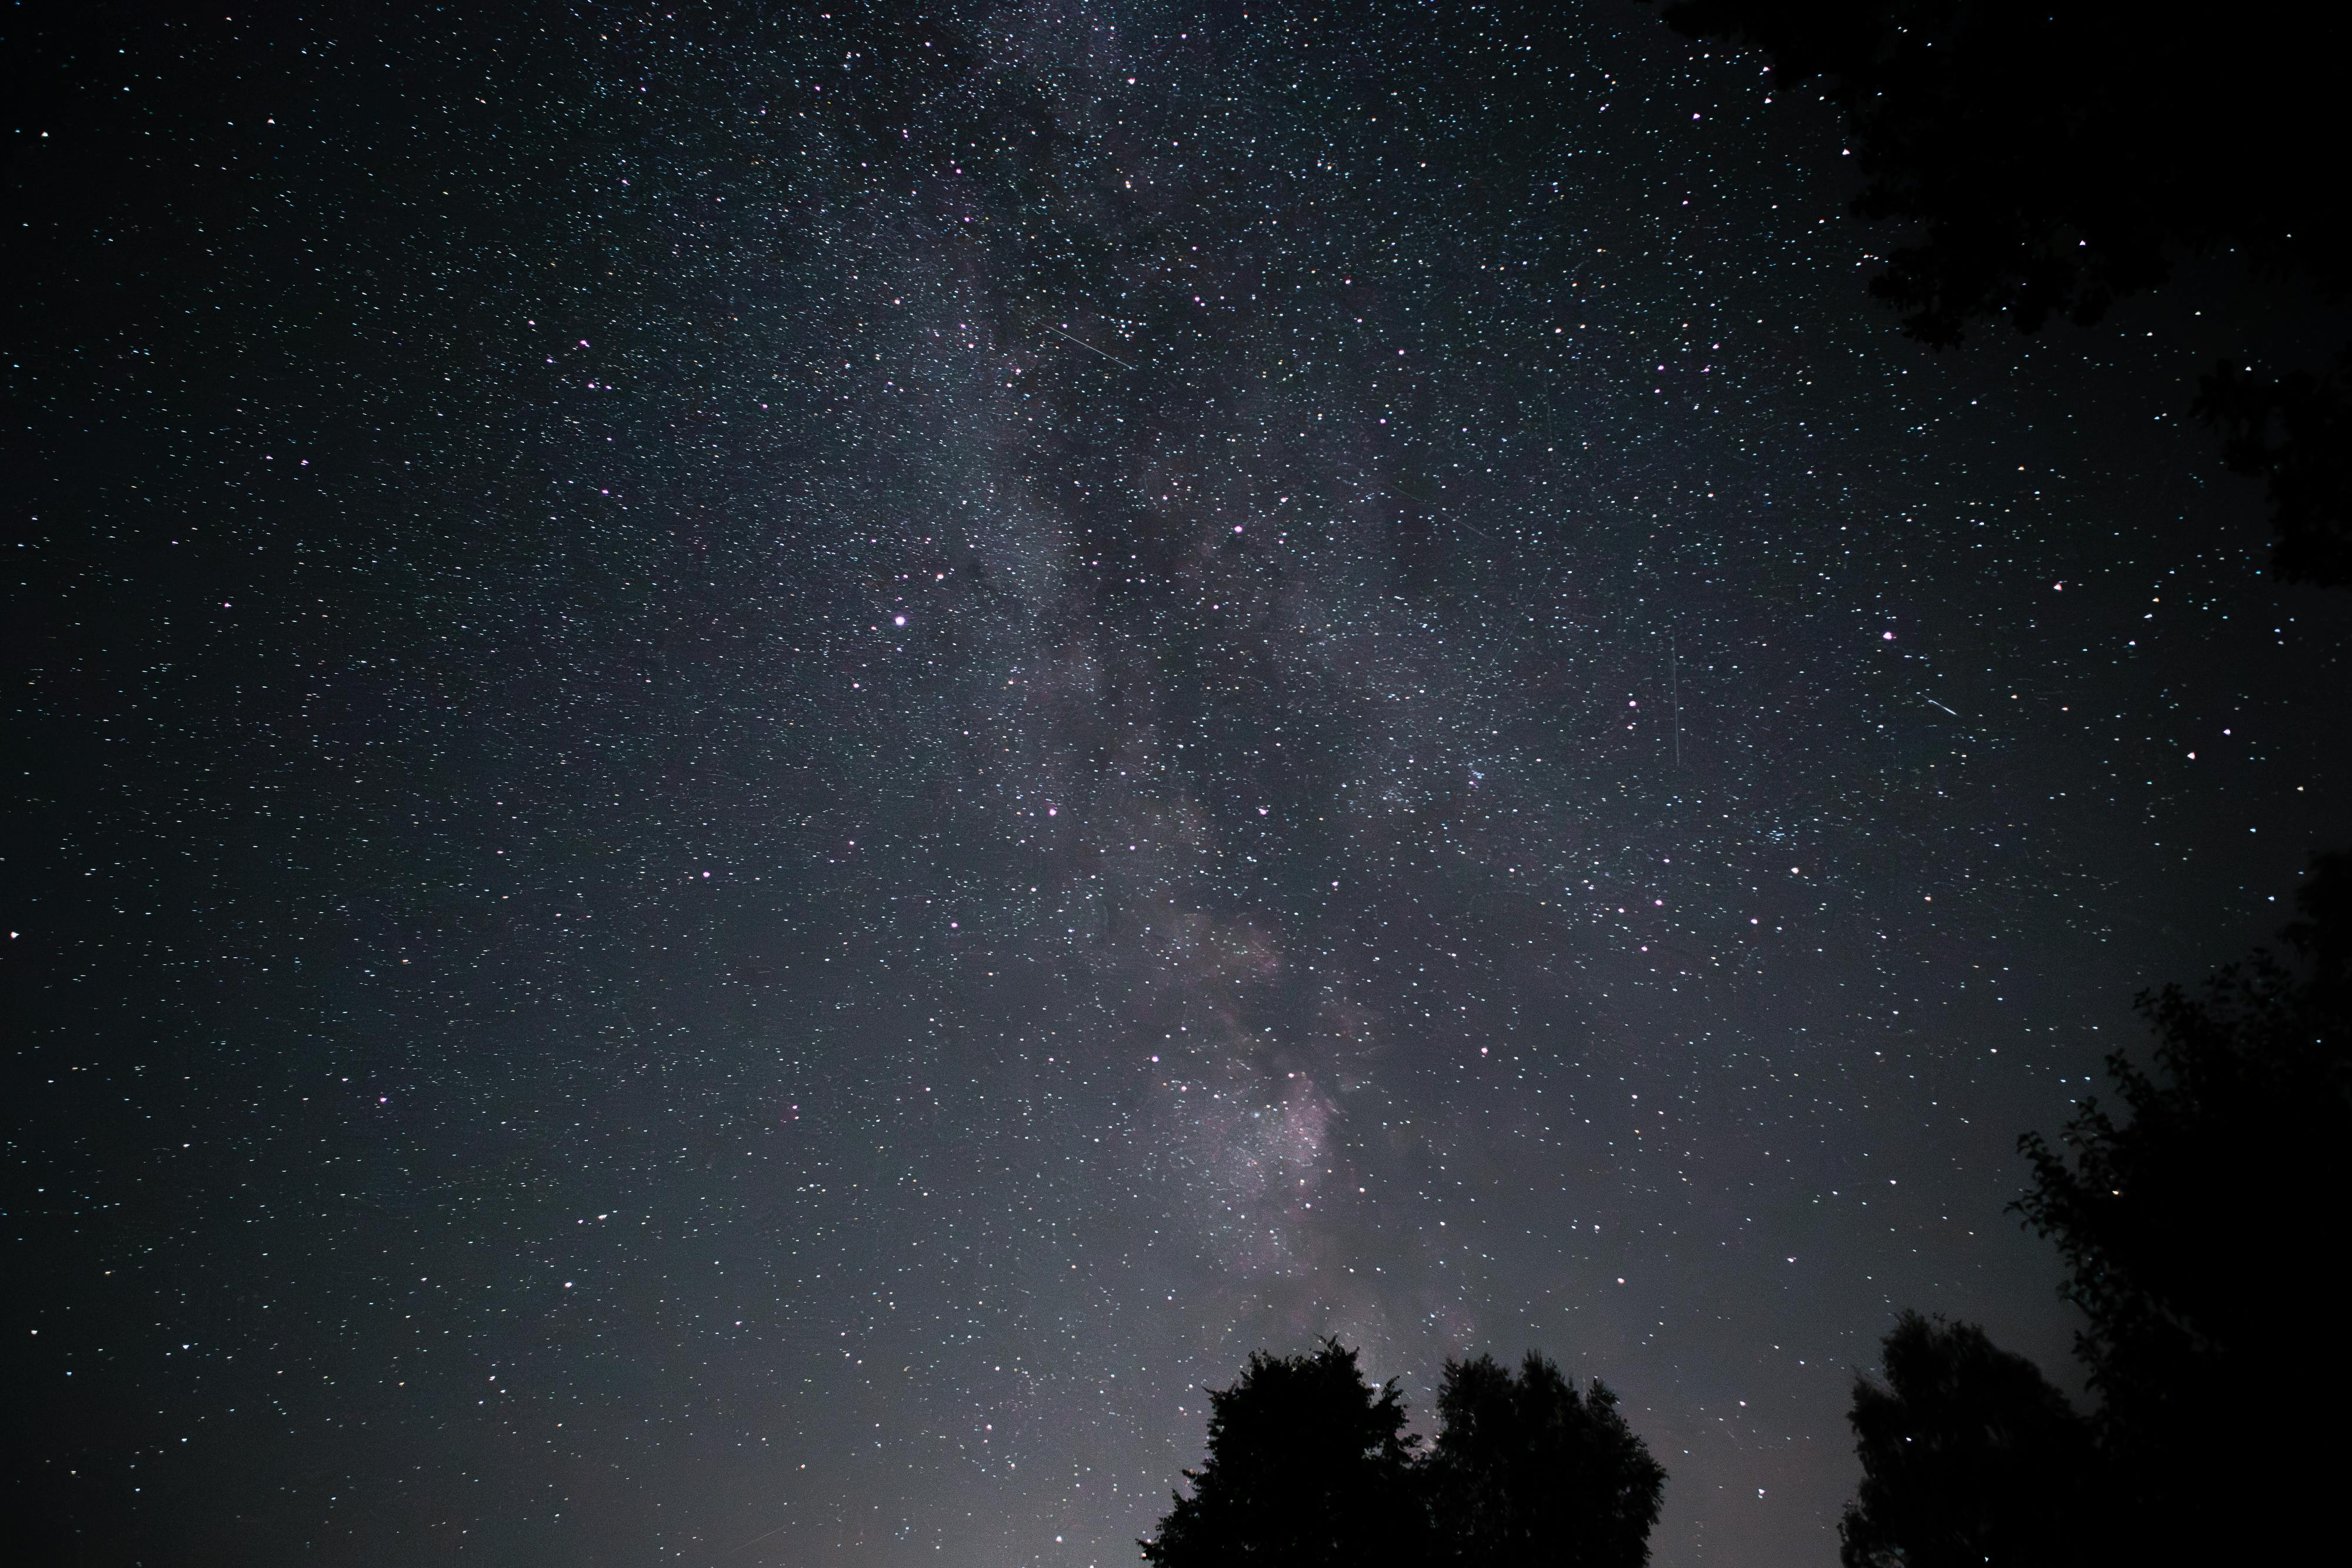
left=2018, top=853, right=2352, bottom=1556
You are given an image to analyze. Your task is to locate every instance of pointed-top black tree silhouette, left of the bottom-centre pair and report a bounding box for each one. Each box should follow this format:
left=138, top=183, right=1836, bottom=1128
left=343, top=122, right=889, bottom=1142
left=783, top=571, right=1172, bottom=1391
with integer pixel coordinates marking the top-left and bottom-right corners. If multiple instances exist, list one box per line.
left=1138, top=1340, right=1428, bottom=1568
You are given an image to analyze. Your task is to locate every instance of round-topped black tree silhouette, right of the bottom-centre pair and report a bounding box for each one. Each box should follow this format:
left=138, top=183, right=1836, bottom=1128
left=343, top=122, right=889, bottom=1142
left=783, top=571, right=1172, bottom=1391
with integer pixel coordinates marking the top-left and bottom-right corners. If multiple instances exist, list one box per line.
left=1428, top=1352, right=1665, bottom=1568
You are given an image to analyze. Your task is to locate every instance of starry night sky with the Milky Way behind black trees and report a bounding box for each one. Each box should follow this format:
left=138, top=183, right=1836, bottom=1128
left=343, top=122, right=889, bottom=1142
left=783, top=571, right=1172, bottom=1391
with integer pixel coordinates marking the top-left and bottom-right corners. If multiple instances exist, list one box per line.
left=5, top=0, right=2352, bottom=1568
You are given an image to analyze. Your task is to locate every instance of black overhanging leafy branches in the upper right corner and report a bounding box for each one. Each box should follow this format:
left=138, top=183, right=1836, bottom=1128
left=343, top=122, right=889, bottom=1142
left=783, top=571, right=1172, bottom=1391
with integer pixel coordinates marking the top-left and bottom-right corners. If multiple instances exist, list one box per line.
left=1637, top=0, right=2352, bottom=586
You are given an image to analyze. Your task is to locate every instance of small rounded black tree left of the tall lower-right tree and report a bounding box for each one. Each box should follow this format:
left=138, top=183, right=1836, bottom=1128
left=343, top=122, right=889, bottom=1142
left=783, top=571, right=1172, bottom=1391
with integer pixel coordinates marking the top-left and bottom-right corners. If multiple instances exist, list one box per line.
left=1837, top=1312, right=2100, bottom=1568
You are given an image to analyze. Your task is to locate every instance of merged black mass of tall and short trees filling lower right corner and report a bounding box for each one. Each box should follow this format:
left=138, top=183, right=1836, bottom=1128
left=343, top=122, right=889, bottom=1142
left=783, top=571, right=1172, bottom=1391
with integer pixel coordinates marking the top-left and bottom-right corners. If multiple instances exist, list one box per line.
left=1839, top=853, right=2352, bottom=1568
